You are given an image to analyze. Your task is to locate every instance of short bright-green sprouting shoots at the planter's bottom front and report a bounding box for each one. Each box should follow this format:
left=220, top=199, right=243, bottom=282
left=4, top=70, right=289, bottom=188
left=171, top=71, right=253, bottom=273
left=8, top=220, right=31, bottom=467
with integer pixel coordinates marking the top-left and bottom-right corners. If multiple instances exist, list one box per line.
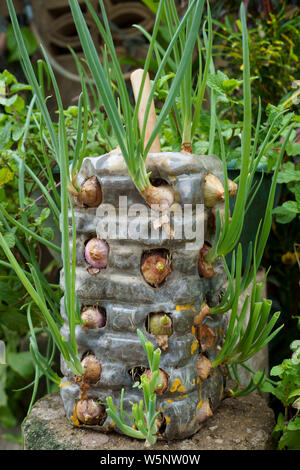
left=106, top=330, right=161, bottom=446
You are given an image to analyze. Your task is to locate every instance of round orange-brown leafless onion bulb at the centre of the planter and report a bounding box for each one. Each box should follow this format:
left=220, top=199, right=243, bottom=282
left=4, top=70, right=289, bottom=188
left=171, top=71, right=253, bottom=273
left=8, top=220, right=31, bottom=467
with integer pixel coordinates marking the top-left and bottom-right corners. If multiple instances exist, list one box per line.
left=141, top=253, right=171, bottom=287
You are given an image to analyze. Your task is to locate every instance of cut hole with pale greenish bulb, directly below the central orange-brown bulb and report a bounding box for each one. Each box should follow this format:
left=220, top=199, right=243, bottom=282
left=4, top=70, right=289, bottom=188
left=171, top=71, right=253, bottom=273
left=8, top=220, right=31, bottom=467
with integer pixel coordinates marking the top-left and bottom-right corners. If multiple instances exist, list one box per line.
left=145, top=312, right=173, bottom=351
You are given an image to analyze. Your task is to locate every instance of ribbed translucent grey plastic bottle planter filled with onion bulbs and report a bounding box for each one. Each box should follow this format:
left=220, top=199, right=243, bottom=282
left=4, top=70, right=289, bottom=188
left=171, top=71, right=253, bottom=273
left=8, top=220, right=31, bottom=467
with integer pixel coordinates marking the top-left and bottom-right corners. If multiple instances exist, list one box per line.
left=61, top=152, right=225, bottom=439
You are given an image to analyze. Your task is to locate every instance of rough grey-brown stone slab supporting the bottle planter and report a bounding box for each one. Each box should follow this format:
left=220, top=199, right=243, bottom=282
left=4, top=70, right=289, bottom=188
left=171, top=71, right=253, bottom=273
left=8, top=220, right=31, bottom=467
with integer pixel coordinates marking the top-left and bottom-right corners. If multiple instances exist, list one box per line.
left=24, top=393, right=276, bottom=451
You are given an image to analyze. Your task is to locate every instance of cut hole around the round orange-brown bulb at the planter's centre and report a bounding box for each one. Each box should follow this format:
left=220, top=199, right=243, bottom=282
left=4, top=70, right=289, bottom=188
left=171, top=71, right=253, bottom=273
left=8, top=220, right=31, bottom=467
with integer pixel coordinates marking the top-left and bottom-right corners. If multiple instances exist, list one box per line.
left=141, top=249, right=171, bottom=287
